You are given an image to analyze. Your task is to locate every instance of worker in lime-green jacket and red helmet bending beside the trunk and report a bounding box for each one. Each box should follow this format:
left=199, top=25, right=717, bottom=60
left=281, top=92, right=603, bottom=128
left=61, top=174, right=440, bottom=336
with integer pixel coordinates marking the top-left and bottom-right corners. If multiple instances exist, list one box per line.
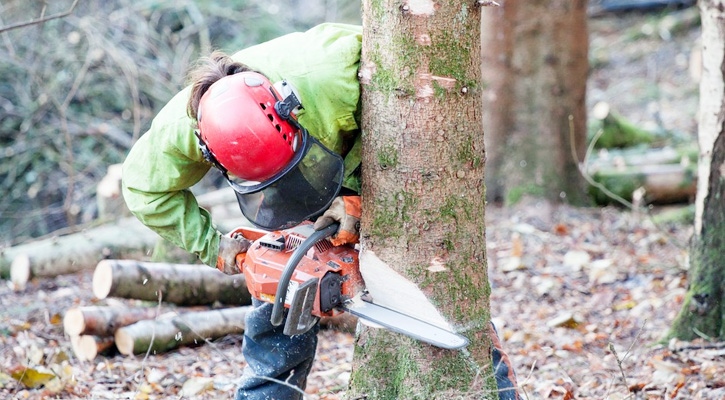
left=123, top=23, right=518, bottom=399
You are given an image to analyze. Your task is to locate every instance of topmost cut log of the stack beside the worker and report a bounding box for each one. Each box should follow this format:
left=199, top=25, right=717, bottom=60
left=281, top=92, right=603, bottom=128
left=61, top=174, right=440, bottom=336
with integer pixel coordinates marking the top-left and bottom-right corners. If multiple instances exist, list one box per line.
left=93, top=260, right=252, bottom=306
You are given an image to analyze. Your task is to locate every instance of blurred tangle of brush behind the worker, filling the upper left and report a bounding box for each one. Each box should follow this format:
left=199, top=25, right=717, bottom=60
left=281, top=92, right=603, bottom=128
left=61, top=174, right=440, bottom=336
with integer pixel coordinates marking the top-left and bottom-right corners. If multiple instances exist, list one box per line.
left=0, top=0, right=359, bottom=244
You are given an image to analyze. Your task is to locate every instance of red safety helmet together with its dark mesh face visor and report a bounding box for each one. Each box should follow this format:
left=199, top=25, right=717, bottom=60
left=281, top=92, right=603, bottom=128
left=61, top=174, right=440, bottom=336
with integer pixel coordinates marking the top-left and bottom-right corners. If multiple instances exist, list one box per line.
left=195, top=72, right=344, bottom=230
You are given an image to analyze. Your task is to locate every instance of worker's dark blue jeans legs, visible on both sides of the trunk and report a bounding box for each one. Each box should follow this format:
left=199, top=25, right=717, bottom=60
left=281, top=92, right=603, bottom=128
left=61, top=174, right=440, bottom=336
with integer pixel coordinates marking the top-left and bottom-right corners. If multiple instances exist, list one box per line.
left=235, top=299, right=519, bottom=400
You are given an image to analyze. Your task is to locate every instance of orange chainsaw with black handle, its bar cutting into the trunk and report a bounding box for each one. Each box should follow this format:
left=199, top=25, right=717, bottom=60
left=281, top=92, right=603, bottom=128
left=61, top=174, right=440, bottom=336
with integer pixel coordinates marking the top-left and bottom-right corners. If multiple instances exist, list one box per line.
left=232, top=223, right=468, bottom=349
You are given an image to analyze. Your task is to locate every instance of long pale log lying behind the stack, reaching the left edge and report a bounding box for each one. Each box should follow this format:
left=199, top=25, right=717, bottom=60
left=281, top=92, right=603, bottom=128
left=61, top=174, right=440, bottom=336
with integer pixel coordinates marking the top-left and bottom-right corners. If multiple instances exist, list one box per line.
left=5, top=218, right=158, bottom=289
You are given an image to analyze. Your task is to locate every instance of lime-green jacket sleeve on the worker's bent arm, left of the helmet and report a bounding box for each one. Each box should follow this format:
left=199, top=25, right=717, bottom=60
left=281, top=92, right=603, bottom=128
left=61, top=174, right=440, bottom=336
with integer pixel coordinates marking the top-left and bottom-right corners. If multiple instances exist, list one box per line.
left=123, top=88, right=221, bottom=266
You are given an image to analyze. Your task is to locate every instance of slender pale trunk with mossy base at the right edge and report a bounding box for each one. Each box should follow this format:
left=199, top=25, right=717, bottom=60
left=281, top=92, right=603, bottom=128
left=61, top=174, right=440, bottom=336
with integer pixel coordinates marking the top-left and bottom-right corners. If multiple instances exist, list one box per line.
left=668, top=0, right=725, bottom=340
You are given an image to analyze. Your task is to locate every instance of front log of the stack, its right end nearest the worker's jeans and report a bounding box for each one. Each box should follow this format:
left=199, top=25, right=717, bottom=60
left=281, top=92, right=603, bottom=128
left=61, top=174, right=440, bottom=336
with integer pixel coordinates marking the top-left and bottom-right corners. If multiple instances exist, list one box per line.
left=114, top=306, right=251, bottom=355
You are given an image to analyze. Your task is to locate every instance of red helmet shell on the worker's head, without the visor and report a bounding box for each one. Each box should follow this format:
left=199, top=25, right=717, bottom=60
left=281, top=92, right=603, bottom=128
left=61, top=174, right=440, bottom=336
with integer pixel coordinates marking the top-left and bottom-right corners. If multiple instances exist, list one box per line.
left=197, top=72, right=302, bottom=182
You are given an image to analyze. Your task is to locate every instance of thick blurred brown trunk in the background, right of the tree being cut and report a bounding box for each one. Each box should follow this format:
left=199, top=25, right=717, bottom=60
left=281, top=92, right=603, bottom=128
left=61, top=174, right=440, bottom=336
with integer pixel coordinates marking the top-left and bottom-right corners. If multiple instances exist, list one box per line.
left=482, top=0, right=588, bottom=204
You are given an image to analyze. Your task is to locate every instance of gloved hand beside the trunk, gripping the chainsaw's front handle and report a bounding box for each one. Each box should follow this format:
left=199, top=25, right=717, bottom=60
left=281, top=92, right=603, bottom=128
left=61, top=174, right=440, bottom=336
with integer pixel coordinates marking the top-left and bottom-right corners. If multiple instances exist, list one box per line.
left=315, top=196, right=360, bottom=246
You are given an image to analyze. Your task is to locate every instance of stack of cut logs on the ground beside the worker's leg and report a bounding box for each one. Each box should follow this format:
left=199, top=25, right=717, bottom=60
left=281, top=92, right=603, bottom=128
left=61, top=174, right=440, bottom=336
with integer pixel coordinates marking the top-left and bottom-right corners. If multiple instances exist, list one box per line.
left=63, top=260, right=251, bottom=360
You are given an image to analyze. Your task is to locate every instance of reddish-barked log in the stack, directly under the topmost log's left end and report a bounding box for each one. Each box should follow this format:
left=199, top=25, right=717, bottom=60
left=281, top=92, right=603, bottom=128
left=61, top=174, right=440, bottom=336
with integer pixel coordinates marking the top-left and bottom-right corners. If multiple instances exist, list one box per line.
left=63, top=306, right=157, bottom=337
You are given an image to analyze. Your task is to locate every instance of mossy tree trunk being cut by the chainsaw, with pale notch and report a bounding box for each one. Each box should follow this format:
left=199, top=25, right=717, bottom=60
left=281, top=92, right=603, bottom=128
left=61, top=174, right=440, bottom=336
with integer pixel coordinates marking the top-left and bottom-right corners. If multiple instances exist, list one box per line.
left=348, top=1, right=497, bottom=399
